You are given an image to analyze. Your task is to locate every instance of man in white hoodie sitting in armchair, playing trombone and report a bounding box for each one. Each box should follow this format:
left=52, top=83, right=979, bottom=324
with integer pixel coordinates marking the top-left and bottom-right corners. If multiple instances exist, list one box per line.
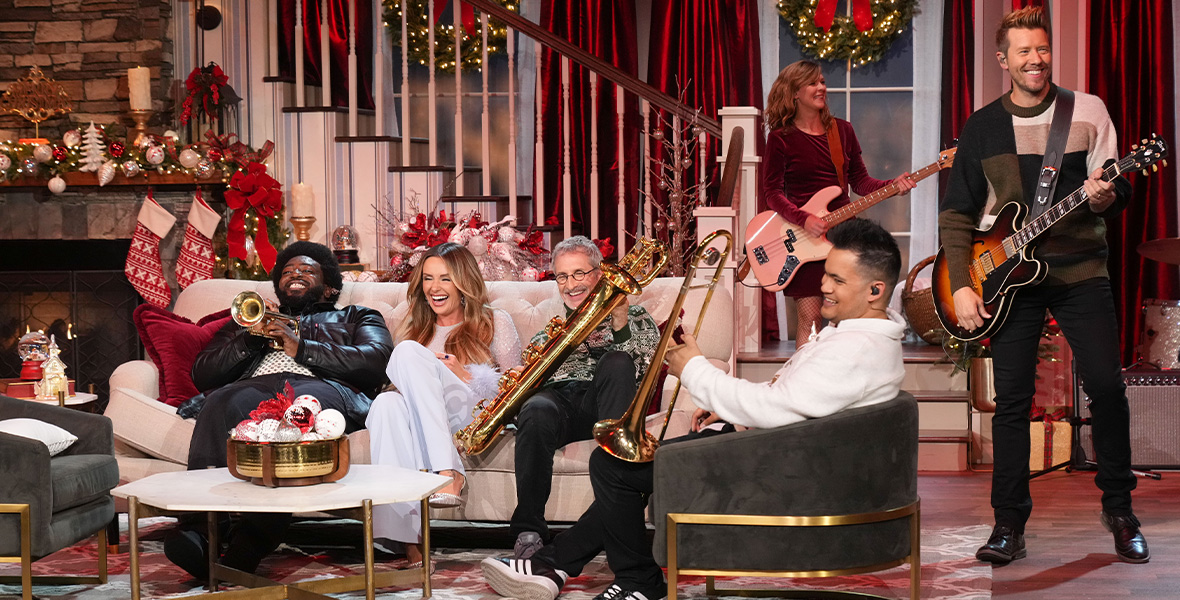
left=481, top=219, right=905, bottom=600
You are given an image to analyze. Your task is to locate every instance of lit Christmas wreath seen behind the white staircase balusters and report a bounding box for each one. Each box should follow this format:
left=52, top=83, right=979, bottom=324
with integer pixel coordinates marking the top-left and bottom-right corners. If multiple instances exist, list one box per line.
left=381, top=0, right=520, bottom=73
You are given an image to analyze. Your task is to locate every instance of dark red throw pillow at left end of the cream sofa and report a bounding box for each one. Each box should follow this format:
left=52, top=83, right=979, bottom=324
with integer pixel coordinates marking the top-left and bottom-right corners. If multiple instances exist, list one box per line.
left=133, top=305, right=230, bottom=406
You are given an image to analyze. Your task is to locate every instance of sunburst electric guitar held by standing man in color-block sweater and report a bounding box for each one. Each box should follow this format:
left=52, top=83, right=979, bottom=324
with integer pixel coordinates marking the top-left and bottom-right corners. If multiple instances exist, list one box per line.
left=931, top=133, right=1168, bottom=340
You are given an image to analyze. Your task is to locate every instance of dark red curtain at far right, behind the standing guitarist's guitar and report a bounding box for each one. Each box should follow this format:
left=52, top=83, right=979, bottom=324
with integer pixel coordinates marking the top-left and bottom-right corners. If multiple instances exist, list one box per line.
left=1089, top=0, right=1178, bottom=365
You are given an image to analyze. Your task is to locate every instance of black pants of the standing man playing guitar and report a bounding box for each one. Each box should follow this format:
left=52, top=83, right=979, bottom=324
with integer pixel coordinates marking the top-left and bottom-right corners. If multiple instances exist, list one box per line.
left=991, top=278, right=1136, bottom=531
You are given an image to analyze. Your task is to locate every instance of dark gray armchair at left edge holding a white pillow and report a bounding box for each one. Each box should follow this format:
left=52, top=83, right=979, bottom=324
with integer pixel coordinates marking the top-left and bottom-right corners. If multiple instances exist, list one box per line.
left=0, top=396, right=119, bottom=600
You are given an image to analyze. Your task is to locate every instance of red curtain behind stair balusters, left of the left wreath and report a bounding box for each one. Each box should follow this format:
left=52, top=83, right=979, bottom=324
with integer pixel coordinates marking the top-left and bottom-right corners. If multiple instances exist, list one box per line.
left=278, top=0, right=372, bottom=109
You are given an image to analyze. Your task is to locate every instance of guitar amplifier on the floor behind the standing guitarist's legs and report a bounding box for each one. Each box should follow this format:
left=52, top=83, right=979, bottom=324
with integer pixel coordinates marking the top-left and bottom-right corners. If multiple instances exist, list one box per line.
left=1080, top=370, right=1180, bottom=469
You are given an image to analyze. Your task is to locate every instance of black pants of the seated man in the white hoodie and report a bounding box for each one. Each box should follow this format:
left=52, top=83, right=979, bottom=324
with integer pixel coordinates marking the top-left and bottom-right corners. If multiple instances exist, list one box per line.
left=533, top=425, right=734, bottom=598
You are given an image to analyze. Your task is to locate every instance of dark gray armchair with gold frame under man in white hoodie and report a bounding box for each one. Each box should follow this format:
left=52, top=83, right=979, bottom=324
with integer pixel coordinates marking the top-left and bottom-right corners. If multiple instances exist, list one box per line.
left=651, top=392, right=920, bottom=600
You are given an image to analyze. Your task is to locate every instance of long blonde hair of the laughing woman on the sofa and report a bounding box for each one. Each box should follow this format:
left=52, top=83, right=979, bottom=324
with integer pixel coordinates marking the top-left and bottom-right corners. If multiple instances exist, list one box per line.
left=398, top=242, right=496, bottom=365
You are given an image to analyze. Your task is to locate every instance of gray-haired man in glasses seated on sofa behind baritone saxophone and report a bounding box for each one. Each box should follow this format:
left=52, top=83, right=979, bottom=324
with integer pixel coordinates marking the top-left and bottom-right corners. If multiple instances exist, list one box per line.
left=511, top=235, right=660, bottom=559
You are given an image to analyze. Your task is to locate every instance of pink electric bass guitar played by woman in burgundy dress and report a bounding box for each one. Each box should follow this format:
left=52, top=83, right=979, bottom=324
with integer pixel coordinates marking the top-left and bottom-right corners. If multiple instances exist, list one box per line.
left=746, top=148, right=955, bottom=292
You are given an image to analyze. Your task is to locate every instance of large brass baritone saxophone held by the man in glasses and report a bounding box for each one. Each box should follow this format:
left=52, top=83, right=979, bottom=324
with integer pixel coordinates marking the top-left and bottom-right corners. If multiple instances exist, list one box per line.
left=454, top=237, right=669, bottom=455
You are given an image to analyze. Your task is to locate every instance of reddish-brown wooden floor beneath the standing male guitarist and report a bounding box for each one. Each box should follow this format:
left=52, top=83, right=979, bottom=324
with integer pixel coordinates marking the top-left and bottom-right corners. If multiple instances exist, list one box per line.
left=918, top=471, right=1180, bottom=600
